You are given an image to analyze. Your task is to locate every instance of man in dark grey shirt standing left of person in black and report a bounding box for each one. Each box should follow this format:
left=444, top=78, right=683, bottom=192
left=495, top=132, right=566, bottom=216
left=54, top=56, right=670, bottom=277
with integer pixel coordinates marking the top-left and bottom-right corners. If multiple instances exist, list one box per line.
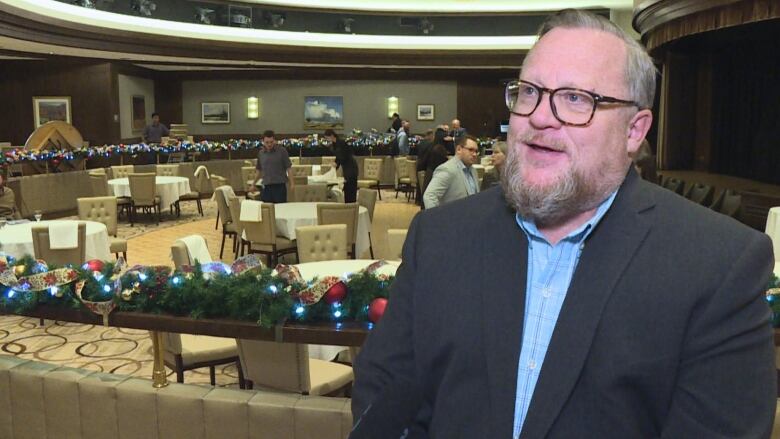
left=257, top=130, right=295, bottom=203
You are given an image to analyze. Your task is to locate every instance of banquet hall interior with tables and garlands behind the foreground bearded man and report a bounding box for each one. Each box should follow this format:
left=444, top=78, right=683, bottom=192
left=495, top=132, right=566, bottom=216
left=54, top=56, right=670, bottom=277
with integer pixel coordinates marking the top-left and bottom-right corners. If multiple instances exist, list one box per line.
left=0, top=0, right=780, bottom=439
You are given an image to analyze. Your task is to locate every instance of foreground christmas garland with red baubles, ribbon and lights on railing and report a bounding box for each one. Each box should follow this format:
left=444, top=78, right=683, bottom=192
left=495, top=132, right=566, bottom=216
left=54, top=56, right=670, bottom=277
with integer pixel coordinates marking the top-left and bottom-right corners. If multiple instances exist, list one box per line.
left=0, top=255, right=393, bottom=328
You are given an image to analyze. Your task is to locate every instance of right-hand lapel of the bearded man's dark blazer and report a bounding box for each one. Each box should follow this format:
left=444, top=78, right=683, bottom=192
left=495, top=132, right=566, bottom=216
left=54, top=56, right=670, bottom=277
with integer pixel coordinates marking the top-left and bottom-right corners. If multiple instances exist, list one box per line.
left=521, top=172, right=653, bottom=438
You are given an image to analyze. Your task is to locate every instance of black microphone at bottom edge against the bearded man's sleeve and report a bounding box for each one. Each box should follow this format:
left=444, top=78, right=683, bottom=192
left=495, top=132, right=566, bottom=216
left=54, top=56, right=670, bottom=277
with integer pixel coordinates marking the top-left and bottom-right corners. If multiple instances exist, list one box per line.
left=349, top=378, right=427, bottom=439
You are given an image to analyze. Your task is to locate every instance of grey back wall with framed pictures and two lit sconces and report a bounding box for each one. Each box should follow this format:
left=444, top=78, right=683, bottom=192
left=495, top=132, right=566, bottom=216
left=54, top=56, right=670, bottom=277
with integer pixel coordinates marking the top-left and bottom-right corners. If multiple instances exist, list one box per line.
left=182, top=80, right=457, bottom=135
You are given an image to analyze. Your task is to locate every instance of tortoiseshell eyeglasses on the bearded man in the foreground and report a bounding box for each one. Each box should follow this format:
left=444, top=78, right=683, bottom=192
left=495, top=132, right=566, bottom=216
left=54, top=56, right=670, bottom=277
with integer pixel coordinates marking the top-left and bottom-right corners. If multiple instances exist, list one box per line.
left=504, top=81, right=639, bottom=127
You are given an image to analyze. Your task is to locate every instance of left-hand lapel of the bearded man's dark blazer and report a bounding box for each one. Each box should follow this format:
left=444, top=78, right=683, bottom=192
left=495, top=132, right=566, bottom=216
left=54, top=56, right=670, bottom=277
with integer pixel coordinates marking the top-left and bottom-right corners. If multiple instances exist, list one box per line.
left=478, top=192, right=528, bottom=438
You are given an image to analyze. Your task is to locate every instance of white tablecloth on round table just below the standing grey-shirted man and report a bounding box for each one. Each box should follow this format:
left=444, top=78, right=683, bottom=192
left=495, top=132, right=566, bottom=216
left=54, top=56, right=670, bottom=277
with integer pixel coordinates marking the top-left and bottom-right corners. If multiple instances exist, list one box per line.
left=274, top=203, right=371, bottom=257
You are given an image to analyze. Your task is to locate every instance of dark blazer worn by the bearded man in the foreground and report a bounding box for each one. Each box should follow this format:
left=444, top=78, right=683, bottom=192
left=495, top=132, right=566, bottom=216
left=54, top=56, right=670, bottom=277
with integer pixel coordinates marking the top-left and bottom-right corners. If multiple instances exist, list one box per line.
left=352, top=170, right=777, bottom=439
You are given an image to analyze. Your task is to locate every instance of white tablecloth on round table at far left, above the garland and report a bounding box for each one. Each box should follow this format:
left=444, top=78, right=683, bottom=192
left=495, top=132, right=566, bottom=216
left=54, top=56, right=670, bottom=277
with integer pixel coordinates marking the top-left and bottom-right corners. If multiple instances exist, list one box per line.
left=0, top=221, right=111, bottom=261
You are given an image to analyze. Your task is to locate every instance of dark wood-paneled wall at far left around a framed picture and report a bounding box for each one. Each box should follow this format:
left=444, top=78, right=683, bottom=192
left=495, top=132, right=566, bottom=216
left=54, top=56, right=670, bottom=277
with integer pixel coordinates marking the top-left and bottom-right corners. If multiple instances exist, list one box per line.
left=0, top=61, right=119, bottom=145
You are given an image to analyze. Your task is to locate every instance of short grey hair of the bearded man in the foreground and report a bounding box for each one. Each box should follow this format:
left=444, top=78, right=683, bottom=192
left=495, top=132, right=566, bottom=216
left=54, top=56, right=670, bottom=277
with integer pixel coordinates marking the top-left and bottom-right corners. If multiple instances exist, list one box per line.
left=526, top=9, right=657, bottom=109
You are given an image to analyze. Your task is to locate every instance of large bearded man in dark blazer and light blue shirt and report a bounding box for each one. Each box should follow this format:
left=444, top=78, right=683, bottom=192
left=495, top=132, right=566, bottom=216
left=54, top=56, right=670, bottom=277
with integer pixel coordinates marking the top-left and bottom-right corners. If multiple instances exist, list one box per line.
left=352, top=10, right=776, bottom=439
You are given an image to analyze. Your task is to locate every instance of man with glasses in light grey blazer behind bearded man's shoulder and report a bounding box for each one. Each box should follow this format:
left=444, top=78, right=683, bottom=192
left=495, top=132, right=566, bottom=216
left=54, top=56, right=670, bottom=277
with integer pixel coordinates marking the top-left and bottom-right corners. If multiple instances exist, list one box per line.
left=423, top=135, right=479, bottom=209
